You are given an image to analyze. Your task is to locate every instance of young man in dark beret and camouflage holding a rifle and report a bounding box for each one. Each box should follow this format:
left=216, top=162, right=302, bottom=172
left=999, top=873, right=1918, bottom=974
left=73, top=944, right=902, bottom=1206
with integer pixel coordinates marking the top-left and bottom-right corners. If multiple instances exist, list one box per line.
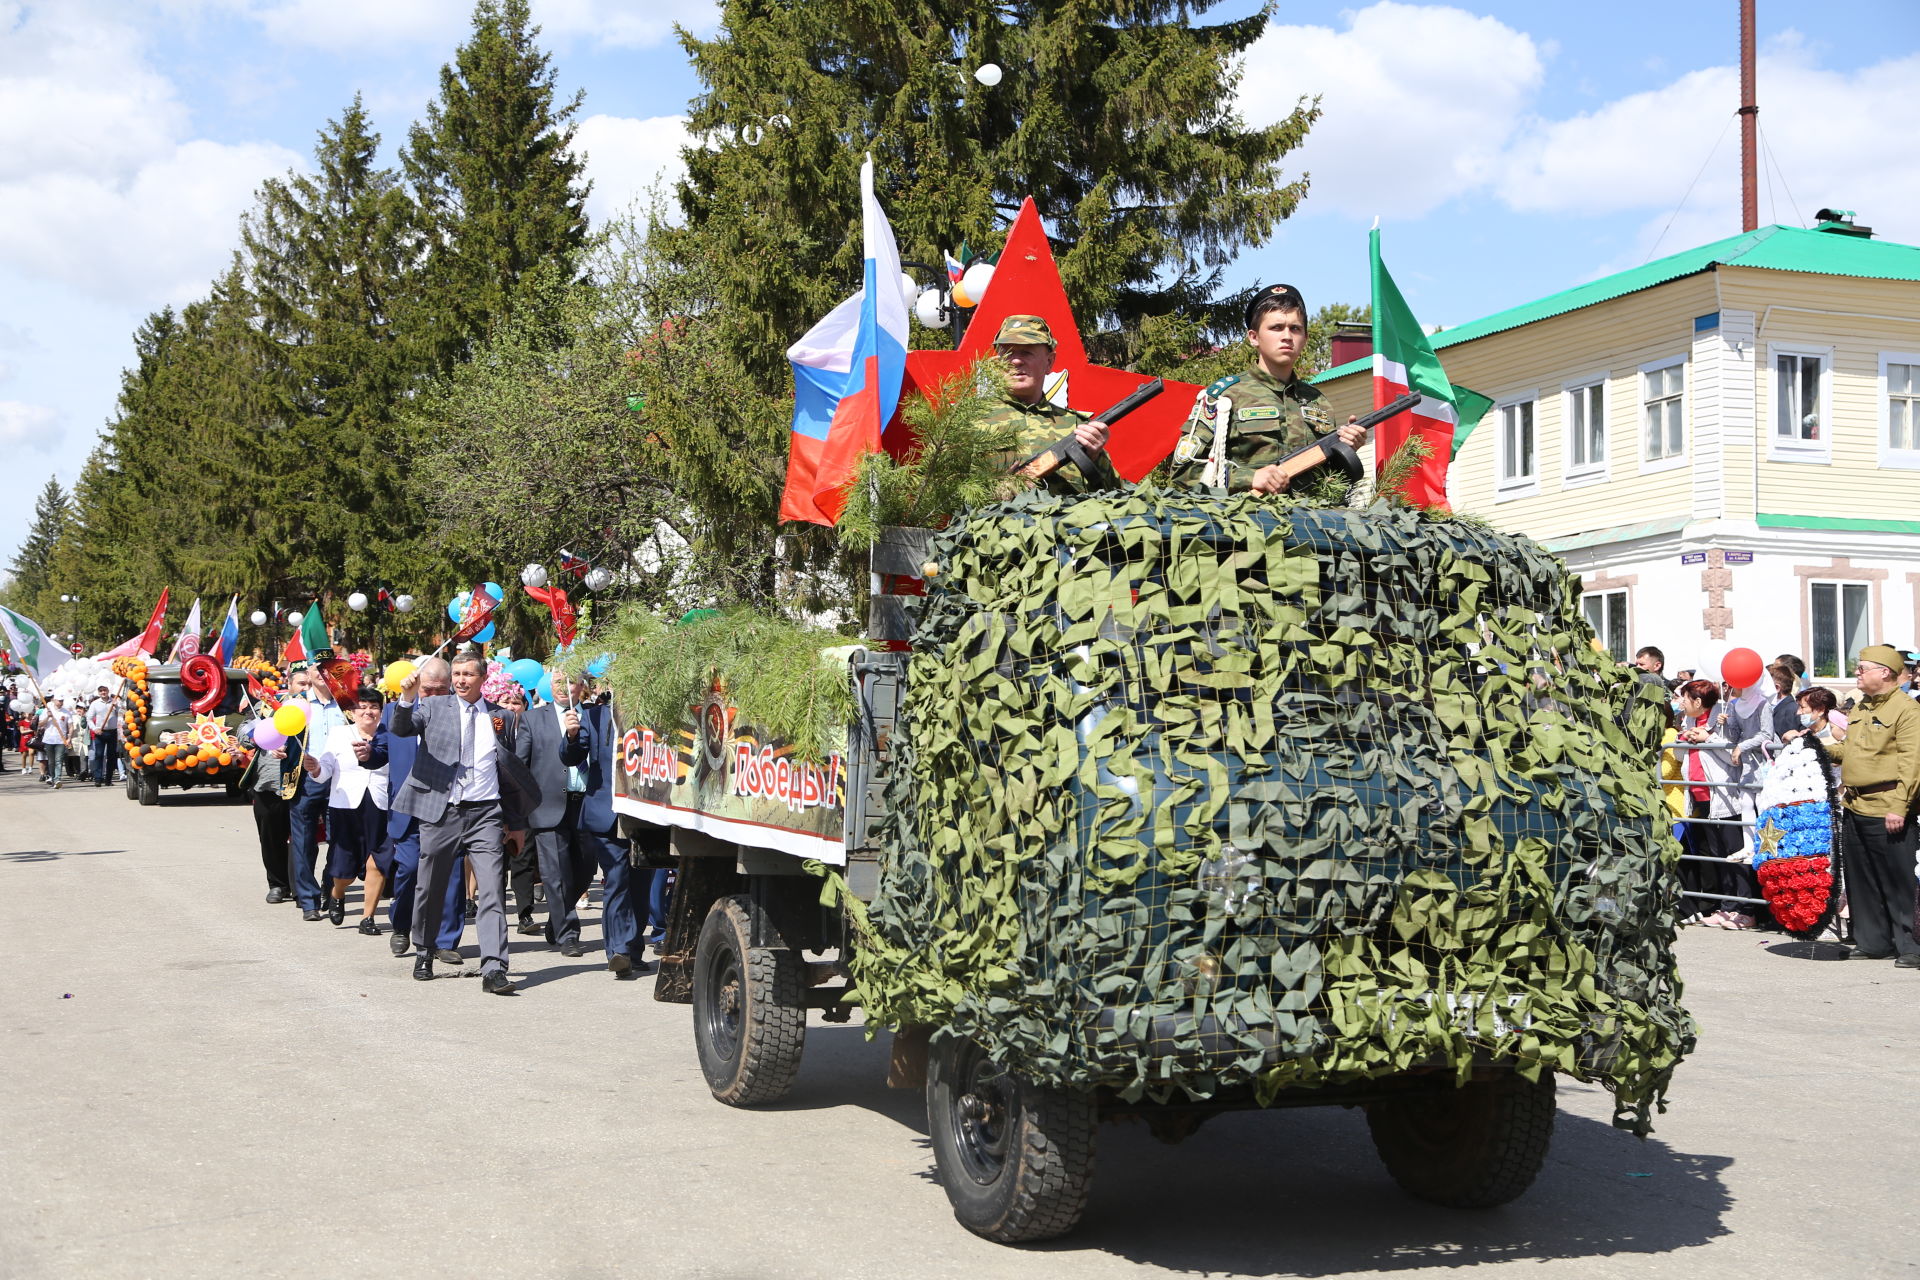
left=1173, top=284, right=1367, bottom=493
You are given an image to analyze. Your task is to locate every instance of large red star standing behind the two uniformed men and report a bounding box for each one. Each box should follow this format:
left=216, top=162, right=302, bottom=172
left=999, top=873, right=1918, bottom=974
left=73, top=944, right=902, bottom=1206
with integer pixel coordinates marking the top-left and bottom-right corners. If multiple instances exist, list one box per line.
left=887, top=198, right=1200, bottom=480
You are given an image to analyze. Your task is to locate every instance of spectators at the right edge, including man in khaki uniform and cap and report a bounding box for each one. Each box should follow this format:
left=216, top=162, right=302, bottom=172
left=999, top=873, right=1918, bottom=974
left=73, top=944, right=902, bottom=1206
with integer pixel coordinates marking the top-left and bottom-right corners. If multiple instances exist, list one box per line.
left=1634, top=645, right=1920, bottom=969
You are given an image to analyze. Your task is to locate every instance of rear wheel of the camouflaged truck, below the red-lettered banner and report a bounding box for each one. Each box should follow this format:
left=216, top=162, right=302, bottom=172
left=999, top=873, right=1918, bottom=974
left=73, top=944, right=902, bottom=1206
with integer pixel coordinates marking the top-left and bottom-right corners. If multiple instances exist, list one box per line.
left=693, top=894, right=806, bottom=1107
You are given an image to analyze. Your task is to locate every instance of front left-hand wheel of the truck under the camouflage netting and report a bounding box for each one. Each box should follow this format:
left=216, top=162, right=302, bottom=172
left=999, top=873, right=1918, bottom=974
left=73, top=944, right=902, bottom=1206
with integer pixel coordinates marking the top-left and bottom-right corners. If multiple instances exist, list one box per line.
left=927, top=1036, right=1098, bottom=1244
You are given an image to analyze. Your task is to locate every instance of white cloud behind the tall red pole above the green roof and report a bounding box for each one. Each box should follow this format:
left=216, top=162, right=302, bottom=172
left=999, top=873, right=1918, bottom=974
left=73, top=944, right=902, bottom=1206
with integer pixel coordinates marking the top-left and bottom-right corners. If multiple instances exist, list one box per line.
left=1496, top=38, right=1920, bottom=251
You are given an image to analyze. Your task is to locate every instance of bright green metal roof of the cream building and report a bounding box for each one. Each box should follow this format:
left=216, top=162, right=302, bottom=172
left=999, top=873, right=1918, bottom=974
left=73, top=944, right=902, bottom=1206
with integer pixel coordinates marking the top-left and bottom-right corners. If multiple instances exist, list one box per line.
left=1313, top=225, right=1920, bottom=382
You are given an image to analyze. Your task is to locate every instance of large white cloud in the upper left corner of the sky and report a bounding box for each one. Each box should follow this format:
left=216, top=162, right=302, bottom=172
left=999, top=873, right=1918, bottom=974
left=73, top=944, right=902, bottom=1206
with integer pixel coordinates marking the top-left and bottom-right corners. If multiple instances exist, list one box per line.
left=0, top=4, right=301, bottom=305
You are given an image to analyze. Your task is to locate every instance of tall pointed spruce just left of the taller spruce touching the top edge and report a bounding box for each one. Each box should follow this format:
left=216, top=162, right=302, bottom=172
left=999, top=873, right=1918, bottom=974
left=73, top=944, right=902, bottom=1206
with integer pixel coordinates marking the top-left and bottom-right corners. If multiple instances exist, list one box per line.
left=242, top=96, right=428, bottom=593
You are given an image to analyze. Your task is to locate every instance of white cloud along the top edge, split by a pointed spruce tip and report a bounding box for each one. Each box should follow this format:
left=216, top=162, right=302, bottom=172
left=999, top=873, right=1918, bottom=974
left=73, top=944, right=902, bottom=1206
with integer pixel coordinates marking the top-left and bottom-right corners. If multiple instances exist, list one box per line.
left=252, top=0, right=718, bottom=54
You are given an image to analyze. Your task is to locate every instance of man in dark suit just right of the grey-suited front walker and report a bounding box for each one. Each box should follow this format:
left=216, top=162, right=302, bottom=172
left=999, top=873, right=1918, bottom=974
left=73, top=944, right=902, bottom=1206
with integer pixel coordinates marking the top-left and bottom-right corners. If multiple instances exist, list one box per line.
left=515, top=679, right=593, bottom=958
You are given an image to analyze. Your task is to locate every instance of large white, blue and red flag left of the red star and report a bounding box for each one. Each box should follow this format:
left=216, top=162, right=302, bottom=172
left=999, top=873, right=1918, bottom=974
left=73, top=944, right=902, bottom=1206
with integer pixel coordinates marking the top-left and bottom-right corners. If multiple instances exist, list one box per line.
left=780, top=155, right=906, bottom=524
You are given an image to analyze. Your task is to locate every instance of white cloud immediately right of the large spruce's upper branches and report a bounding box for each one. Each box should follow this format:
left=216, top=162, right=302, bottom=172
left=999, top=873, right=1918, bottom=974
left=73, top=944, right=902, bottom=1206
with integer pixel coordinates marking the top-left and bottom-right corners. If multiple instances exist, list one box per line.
left=1240, top=0, right=1544, bottom=217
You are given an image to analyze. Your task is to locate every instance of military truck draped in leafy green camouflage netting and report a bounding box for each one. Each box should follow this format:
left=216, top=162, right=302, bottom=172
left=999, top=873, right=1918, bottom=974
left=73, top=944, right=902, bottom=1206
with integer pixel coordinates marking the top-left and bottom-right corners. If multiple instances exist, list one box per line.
left=622, top=489, right=1693, bottom=1242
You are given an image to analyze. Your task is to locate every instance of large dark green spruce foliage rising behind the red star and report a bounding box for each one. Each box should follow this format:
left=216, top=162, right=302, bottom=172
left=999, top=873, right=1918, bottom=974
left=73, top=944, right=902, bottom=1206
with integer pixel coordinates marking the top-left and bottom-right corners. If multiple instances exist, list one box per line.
left=674, top=0, right=1317, bottom=391
